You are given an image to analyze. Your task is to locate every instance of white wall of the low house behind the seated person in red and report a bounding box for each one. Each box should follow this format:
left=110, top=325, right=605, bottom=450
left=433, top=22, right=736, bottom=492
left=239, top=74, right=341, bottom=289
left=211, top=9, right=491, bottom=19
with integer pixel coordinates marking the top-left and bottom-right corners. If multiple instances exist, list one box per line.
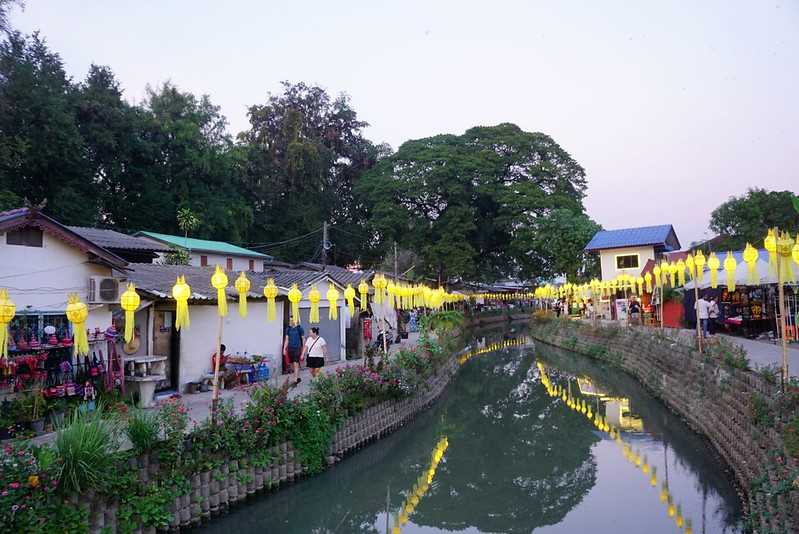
left=178, top=300, right=283, bottom=392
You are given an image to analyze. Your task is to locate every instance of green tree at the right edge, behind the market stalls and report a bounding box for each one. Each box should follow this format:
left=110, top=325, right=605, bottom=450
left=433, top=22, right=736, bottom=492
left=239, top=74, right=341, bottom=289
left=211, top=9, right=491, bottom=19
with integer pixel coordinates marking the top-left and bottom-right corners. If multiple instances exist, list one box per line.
left=710, top=188, right=799, bottom=250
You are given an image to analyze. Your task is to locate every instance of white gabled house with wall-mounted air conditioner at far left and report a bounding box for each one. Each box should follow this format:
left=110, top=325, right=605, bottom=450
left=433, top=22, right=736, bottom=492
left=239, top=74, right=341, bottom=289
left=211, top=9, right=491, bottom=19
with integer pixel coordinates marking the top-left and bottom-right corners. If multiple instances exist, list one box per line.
left=0, top=208, right=128, bottom=342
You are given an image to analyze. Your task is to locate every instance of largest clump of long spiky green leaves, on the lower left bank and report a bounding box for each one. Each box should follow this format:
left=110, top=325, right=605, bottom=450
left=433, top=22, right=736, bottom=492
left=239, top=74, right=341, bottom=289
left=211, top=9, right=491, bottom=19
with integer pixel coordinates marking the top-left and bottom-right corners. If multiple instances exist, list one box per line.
left=55, top=410, right=119, bottom=494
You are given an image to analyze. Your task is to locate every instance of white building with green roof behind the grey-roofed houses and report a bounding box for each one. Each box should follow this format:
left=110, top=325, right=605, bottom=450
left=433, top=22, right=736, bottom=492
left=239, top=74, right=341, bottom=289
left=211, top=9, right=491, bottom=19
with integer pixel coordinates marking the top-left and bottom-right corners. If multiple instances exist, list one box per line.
left=135, top=232, right=272, bottom=272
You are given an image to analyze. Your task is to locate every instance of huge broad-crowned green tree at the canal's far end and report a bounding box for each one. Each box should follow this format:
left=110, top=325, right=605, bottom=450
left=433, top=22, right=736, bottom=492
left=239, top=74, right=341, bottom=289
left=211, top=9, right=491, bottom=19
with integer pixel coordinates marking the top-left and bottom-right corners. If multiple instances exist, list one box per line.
left=358, top=124, right=598, bottom=281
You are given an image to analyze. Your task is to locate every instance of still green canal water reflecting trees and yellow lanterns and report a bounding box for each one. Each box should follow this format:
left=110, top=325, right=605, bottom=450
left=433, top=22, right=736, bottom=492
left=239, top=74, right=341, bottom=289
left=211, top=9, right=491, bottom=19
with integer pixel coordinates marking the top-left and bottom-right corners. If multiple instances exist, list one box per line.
left=199, top=330, right=742, bottom=534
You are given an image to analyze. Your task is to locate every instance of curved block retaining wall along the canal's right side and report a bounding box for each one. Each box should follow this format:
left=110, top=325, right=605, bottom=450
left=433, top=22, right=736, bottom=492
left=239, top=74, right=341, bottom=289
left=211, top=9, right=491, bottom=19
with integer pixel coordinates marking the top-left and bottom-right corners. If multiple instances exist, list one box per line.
left=531, top=317, right=799, bottom=533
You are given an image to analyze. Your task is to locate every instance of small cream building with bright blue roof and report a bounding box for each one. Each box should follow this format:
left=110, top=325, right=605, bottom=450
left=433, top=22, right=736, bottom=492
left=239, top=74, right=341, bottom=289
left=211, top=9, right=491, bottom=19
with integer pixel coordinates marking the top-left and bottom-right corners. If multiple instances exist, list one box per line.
left=585, top=224, right=680, bottom=280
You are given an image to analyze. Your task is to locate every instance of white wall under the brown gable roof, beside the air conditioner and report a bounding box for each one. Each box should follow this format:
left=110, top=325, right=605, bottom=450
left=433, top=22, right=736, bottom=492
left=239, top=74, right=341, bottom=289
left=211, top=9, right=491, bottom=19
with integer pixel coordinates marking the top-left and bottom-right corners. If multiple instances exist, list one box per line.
left=0, top=232, right=111, bottom=330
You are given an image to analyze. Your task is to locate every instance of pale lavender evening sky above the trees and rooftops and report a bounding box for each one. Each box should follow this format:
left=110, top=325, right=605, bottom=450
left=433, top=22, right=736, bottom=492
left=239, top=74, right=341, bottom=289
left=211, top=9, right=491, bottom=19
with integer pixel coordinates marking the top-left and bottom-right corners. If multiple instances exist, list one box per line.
left=11, top=0, right=799, bottom=246
